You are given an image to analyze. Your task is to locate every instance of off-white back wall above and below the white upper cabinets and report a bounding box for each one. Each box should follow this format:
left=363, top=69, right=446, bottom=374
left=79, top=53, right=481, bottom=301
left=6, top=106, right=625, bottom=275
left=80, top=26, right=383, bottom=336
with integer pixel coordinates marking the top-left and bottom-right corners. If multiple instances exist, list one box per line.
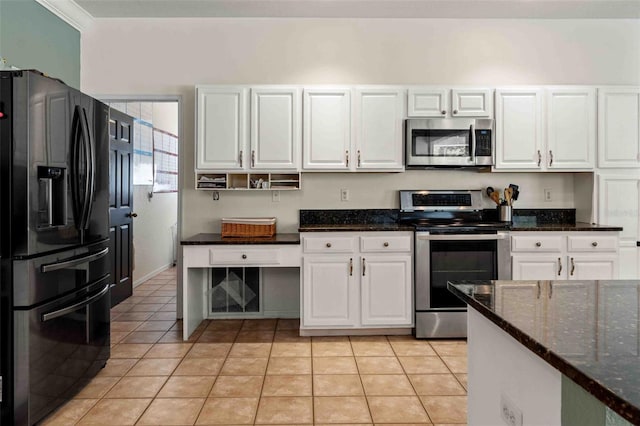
left=81, top=18, right=640, bottom=236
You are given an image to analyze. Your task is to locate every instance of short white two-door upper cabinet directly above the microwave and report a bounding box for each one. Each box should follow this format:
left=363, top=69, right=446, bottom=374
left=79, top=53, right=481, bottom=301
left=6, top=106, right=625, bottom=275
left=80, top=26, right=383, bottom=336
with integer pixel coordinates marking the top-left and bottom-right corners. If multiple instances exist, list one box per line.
left=407, top=87, right=493, bottom=118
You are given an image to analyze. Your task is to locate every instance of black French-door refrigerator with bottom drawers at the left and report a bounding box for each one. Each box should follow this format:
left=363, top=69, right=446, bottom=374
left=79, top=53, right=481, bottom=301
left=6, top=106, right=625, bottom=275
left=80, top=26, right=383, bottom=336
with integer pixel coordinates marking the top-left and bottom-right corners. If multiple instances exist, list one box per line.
left=0, top=71, right=112, bottom=425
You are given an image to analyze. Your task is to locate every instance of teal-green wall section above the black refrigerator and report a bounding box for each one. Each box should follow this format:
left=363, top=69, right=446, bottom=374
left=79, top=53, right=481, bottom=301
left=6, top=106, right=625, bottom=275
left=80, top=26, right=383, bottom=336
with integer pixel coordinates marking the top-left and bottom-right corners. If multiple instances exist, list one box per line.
left=0, top=0, right=80, bottom=89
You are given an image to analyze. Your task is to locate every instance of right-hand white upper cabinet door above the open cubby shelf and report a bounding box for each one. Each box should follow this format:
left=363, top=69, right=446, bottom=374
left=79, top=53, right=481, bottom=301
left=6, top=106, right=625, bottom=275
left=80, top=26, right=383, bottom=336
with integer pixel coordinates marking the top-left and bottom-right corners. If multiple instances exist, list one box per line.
left=250, top=87, right=301, bottom=170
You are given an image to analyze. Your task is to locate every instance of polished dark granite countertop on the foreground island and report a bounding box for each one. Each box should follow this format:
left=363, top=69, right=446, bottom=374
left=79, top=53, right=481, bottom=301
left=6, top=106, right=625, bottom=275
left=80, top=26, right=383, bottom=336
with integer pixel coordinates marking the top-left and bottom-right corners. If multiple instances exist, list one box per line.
left=447, top=280, right=640, bottom=424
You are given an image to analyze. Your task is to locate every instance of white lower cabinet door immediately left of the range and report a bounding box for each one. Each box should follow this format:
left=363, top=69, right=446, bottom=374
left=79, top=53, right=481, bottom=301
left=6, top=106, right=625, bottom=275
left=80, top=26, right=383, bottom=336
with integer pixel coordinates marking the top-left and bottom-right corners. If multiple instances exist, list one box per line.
left=360, top=256, right=413, bottom=326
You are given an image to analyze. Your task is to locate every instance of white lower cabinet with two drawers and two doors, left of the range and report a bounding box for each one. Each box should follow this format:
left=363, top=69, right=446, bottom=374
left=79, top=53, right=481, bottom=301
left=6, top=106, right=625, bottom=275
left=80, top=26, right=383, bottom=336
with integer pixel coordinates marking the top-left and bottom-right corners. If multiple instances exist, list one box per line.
left=300, top=232, right=413, bottom=329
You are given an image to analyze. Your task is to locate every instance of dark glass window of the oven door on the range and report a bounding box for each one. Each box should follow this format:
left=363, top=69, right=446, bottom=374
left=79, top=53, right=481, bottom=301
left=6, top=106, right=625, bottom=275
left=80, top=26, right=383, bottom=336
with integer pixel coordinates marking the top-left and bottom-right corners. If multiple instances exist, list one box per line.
left=429, top=240, right=498, bottom=309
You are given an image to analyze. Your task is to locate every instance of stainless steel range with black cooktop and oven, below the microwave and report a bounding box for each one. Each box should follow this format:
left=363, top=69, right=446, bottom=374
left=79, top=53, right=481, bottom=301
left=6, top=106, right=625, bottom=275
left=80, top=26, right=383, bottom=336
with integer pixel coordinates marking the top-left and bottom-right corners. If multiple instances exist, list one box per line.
left=399, top=190, right=511, bottom=338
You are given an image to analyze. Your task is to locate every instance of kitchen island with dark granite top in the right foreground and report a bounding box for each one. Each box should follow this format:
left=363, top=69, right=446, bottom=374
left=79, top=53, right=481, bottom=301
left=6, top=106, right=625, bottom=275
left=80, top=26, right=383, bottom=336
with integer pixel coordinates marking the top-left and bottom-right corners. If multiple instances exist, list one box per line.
left=448, top=280, right=640, bottom=426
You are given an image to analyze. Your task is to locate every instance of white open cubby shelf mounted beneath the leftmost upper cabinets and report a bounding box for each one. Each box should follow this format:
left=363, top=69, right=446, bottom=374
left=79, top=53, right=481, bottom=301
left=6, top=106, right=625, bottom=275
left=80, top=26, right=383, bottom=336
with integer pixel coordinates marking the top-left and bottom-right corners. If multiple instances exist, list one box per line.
left=196, top=171, right=302, bottom=191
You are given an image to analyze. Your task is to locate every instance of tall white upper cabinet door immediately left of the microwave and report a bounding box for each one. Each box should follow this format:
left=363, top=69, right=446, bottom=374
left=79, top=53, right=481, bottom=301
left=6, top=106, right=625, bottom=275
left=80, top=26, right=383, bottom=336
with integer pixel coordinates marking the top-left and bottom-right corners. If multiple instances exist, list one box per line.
left=354, top=89, right=405, bottom=170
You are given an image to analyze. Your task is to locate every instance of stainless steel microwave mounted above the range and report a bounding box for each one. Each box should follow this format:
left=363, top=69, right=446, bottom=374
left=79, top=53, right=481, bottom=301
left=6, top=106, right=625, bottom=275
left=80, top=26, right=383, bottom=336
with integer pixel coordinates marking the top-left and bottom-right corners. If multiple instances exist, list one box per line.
left=405, top=118, right=494, bottom=168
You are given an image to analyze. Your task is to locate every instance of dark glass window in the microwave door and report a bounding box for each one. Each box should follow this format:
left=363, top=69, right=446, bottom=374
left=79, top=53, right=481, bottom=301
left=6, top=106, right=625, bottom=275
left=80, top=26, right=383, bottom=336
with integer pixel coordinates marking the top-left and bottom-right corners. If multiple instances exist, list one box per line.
left=411, top=129, right=471, bottom=157
